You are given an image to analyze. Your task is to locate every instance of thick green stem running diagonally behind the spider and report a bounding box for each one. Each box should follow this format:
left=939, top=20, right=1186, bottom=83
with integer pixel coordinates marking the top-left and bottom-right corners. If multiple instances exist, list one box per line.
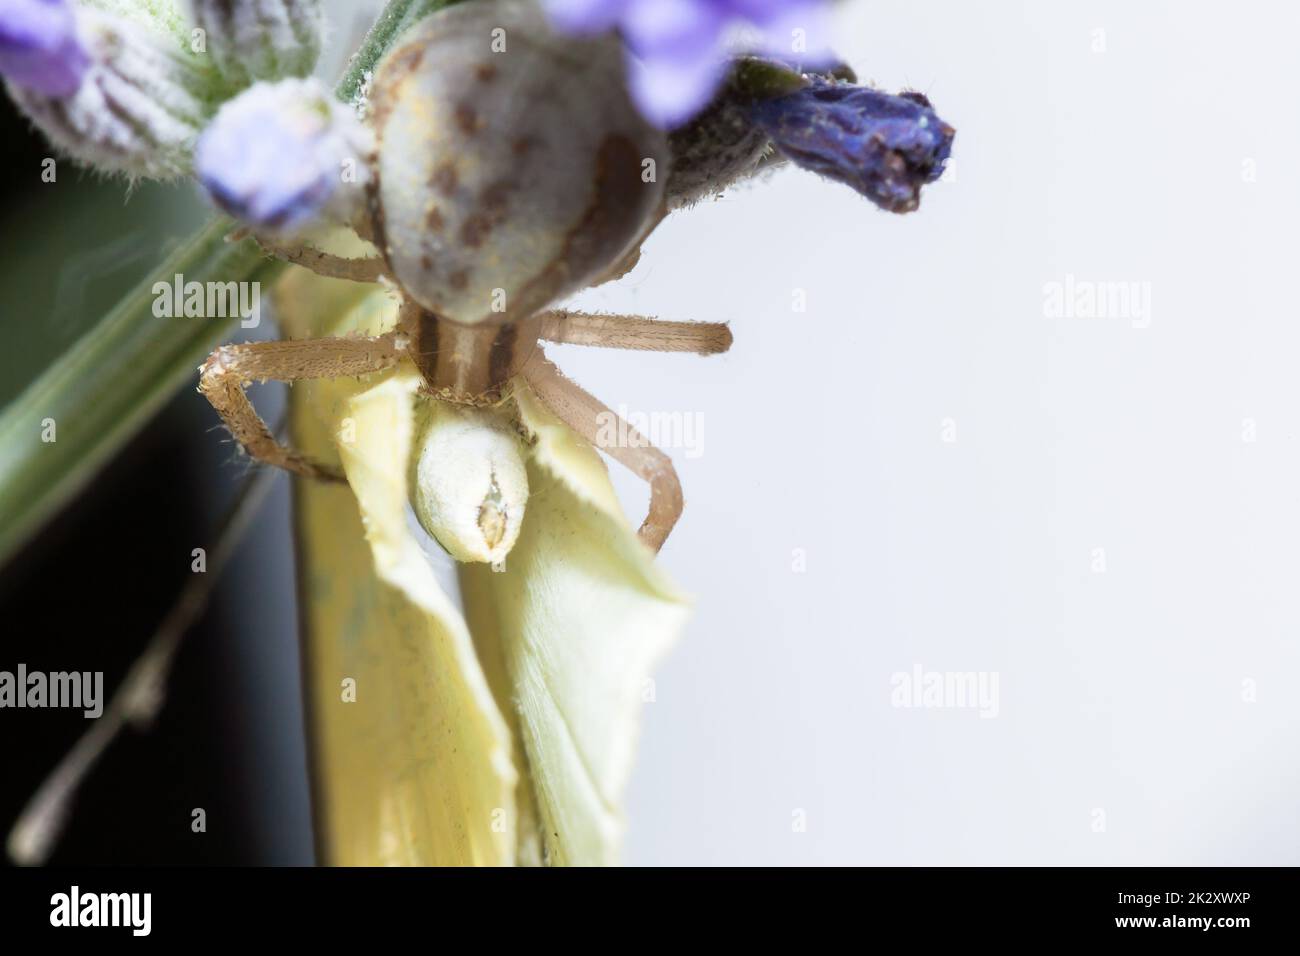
left=0, top=0, right=449, bottom=564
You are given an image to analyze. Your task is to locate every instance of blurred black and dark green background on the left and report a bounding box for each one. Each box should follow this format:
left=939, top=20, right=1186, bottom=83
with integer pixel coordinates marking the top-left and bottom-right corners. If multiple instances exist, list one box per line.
left=0, top=98, right=313, bottom=864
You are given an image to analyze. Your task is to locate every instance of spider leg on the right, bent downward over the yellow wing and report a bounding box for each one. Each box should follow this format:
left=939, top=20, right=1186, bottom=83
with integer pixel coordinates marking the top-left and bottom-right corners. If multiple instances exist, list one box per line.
left=523, top=349, right=683, bottom=551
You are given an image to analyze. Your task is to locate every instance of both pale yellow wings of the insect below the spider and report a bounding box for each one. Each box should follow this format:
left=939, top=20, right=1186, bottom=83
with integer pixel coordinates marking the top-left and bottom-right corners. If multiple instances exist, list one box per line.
left=281, top=264, right=688, bottom=865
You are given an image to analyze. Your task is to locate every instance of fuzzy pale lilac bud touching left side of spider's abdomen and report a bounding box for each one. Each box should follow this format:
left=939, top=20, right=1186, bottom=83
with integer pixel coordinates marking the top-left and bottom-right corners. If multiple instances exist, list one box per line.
left=195, top=79, right=368, bottom=233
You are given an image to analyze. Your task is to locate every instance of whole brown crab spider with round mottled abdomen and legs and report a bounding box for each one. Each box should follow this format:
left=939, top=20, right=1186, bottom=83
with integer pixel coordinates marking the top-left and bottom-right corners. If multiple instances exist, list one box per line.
left=199, top=3, right=732, bottom=551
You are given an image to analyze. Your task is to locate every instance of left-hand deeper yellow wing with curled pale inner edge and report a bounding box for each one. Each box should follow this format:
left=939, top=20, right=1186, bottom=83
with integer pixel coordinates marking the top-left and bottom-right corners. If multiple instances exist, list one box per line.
left=277, top=277, right=516, bottom=865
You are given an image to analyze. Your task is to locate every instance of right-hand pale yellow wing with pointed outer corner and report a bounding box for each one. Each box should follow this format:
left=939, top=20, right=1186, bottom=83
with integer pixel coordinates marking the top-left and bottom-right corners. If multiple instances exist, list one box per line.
left=460, top=382, right=688, bottom=865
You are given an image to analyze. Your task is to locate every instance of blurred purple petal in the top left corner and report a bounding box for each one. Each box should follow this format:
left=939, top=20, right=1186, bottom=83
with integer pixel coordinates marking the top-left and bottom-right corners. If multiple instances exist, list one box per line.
left=0, top=0, right=90, bottom=96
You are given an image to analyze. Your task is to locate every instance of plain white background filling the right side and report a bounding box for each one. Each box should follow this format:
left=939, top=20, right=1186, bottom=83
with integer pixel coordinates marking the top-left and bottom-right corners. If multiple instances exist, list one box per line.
left=533, top=0, right=1300, bottom=864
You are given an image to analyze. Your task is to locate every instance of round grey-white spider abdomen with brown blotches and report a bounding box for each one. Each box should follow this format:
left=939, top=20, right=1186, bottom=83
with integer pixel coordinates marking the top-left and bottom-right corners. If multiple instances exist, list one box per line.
left=369, top=0, right=668, bottom=324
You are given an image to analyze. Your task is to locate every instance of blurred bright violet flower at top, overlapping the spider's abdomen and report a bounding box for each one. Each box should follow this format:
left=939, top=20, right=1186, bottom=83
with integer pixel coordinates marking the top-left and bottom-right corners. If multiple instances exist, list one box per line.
left=546, top=0, right=832, bottom=129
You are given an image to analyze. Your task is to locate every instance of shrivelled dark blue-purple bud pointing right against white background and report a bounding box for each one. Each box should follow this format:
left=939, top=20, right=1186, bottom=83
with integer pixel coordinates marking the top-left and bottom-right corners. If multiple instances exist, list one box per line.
left=750, top=78, right=956, bottom=212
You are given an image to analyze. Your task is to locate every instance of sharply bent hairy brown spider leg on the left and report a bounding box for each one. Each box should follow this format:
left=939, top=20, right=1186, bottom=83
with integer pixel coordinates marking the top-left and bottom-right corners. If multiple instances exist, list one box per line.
left=199, top=332, right=404, bottom=481
